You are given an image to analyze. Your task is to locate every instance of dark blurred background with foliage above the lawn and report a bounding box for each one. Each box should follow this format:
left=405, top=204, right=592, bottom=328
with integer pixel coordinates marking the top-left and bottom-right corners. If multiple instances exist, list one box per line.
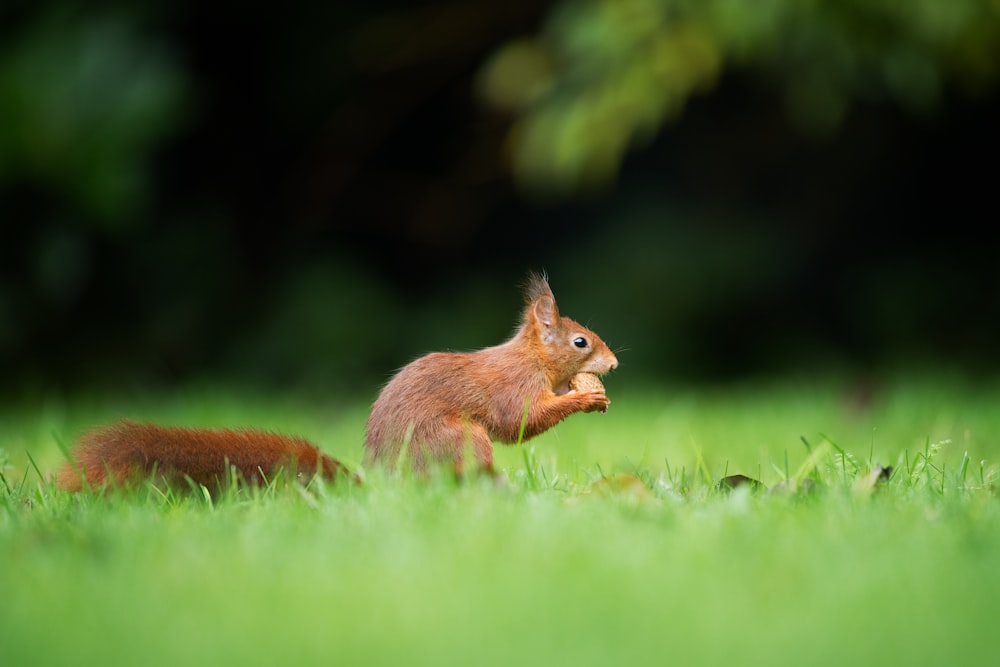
left=0, top=0, right=1000, bottom=400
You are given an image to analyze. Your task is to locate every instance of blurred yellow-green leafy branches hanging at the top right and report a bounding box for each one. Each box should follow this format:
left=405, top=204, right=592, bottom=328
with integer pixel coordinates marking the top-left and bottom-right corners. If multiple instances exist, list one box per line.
left=480, top=0, right=1000, bottom=193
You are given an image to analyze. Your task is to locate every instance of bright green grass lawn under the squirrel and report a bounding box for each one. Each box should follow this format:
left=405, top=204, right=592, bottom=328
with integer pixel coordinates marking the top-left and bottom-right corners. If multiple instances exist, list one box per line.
left=0, top=376, right=1000, bottom=666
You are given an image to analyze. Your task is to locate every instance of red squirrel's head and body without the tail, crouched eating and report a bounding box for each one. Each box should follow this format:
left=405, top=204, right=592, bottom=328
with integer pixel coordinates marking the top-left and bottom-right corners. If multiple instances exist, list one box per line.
left=365, top=273, right=618, bottom=473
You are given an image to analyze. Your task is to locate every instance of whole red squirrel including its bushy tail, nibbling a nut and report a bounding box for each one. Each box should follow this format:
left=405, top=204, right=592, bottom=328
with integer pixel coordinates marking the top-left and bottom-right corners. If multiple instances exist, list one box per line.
left=56, top=274, right=618, bottom=491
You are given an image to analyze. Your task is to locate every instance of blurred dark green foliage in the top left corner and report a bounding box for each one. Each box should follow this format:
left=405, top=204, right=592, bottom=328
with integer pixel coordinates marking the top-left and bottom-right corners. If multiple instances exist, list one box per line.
left=0, top=8, right=186, bottom=225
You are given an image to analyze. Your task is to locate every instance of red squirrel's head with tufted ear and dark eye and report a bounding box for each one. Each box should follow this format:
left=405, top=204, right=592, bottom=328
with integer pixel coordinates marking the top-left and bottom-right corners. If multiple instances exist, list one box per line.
left=524, top=274, right=618, bottom=385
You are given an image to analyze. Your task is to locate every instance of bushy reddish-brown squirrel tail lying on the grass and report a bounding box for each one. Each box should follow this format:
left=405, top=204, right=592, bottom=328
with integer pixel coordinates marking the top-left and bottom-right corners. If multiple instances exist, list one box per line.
left=56, top=420, right=357, bottom=491
